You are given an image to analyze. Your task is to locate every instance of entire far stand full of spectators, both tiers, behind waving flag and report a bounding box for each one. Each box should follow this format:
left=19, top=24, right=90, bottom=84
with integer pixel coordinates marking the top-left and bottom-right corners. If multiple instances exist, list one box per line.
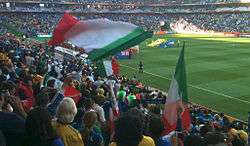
left=0, top=0, right=250, bottom=36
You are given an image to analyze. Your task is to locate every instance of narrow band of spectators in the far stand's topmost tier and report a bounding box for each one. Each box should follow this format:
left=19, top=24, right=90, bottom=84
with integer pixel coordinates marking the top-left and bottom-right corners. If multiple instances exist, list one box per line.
left=0, top=2, right=249, bottom=13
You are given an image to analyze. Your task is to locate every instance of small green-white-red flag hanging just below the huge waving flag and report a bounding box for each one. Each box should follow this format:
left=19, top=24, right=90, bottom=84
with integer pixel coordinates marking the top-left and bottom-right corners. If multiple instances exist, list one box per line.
left=96, top=57, right=120, bottom=77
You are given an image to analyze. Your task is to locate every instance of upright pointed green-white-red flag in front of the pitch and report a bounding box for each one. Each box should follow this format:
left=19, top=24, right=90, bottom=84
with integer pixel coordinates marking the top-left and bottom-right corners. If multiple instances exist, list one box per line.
left=164, top=45, right=191, bottom=134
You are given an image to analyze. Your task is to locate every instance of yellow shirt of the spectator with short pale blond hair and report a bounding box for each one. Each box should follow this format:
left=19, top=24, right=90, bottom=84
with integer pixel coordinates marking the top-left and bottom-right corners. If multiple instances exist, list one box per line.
left=52, top=121, right=84, bottom=146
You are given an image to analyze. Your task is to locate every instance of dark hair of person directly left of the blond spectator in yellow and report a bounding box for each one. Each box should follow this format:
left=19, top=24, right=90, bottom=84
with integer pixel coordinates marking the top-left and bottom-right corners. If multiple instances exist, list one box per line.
left=25, top=107, right=57, bottom=146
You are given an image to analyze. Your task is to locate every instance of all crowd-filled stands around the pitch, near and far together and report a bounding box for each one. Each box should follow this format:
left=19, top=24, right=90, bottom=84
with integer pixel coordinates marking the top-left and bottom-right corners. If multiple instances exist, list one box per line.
left=0, top=0, right=250, bottom=146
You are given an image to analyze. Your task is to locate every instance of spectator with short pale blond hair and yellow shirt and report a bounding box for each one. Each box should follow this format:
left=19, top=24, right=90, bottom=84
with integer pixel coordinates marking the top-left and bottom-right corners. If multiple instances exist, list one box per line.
left=52, top=97, right=84, bottom=146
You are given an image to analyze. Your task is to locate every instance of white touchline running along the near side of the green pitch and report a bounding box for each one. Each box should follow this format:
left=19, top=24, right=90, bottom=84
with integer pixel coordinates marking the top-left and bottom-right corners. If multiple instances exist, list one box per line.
left=120, top=64, right=250, bottom=104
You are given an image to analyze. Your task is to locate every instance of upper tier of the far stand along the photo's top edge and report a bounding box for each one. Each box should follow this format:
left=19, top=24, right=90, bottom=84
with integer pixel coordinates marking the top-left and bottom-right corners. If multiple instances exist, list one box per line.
left=0, top=1, right=250, bottom=14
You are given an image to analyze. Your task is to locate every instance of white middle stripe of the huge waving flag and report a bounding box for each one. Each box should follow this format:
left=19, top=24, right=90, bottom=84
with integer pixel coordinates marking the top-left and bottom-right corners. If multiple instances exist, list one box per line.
left=65, top=19, right=137, bottom=52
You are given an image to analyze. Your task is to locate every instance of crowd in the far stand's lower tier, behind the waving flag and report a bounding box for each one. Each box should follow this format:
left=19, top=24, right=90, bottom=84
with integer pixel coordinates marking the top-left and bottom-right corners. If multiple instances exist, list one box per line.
left=0, top=13, right=250, bottom=36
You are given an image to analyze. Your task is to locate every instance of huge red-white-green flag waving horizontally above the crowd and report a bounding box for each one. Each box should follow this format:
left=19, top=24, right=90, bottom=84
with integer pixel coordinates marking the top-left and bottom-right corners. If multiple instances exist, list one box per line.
left=49, top=13, right=152, bottom=61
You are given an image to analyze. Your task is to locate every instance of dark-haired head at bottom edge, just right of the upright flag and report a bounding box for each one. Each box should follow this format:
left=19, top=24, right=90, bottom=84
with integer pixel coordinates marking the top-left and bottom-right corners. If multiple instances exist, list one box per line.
left=184, top=135, right=206, bottom=146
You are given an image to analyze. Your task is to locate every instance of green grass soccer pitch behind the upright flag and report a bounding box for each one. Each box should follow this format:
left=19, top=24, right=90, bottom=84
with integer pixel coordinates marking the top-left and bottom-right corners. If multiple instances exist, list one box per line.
left=120, top=35, right=250, bottom=121
